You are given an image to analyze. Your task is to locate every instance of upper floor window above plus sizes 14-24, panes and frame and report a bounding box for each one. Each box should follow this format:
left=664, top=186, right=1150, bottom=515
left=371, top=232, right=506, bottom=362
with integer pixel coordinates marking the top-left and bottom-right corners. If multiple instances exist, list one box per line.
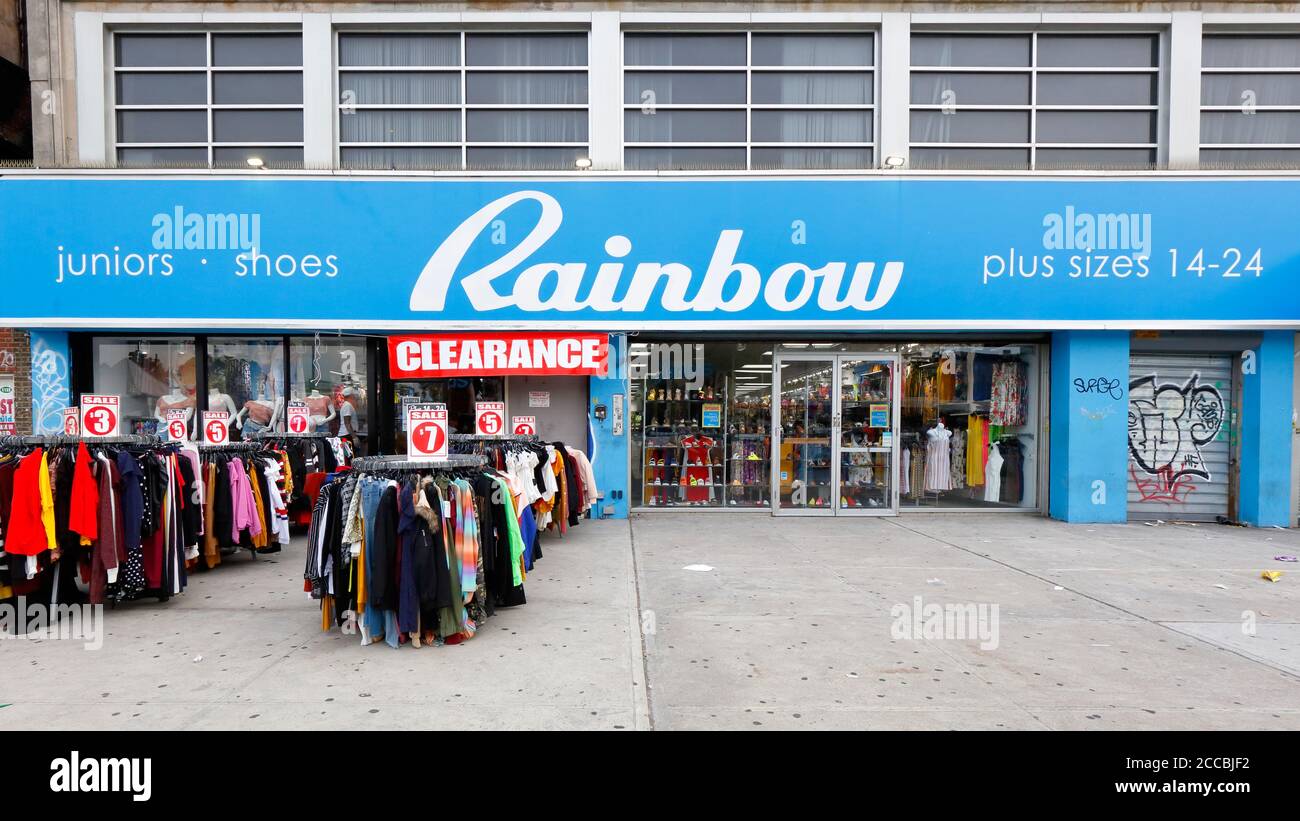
left=910, top=32, right=1160, bottom=169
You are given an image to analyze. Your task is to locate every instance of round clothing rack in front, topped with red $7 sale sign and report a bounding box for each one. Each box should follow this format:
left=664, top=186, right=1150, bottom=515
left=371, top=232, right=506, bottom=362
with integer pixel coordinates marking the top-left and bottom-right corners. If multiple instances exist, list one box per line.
left=303, top=453, right=533, bottom=648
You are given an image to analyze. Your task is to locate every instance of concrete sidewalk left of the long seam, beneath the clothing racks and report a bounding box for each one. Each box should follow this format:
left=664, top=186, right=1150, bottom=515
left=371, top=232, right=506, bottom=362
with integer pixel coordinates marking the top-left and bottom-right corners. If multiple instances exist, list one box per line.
left=0, top=522, right=649, bottom=730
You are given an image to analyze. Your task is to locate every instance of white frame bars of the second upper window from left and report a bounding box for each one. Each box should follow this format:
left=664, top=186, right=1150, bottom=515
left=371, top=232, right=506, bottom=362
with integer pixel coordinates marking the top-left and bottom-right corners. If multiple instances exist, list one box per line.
left=330, top=26, right=594, bottom=171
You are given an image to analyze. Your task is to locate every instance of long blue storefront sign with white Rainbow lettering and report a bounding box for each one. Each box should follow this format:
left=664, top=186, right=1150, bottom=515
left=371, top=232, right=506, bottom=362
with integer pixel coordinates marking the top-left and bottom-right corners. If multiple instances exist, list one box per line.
left=0, top=178, right=1300, bottom=330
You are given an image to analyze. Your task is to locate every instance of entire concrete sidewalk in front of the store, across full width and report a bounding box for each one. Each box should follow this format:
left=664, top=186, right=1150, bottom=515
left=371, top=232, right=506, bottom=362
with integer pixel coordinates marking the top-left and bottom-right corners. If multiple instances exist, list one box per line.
left=0, top=513, right=1300, bottom=730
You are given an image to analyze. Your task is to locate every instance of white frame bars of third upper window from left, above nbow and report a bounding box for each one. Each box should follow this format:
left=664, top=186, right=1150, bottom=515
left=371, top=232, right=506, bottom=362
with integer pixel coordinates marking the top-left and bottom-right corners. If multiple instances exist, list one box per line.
left=619, top=23, right=881, bottom=171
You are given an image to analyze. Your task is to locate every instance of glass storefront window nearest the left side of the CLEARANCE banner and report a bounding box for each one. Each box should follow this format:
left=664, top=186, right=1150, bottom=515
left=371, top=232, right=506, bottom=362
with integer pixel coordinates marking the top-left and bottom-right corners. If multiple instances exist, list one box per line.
left=289, top=338, right=369, bottom=453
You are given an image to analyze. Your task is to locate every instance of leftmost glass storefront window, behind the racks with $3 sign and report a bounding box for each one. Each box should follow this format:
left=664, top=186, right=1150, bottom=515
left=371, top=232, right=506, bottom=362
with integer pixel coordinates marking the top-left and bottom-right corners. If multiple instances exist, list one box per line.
left=94, top=336, right=196, bottom=434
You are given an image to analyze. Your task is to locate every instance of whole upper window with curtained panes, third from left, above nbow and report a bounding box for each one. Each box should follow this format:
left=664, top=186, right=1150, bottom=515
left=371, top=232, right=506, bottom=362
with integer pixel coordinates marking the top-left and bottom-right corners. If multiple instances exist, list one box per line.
left=623, top=31, right=875, bottom=170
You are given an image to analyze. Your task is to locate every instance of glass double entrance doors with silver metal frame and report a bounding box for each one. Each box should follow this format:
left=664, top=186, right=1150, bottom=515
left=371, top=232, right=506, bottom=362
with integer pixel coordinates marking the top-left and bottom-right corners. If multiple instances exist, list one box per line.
left=772, top=352, right=901, bottom=516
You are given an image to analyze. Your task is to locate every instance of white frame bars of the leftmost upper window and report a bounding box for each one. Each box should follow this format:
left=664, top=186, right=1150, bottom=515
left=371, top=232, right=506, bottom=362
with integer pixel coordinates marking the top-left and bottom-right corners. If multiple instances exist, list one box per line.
left=105, top=25, right=308, bottom=168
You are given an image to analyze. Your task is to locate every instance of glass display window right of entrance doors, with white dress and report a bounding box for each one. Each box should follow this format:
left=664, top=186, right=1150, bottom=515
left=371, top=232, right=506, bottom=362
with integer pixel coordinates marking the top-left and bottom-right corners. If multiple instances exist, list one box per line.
left=898, top=343, right=1043, bottom=511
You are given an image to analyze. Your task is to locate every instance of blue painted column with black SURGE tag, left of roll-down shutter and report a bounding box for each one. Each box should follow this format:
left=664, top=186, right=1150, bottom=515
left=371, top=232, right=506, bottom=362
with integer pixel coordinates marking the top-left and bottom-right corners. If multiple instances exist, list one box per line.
left=1048, top=331, right=1128, bottom=522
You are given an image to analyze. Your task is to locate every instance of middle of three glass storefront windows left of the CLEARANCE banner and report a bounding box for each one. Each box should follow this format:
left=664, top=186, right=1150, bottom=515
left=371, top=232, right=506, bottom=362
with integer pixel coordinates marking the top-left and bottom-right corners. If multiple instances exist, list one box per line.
left=205, top=336, right=285, bottom=439
